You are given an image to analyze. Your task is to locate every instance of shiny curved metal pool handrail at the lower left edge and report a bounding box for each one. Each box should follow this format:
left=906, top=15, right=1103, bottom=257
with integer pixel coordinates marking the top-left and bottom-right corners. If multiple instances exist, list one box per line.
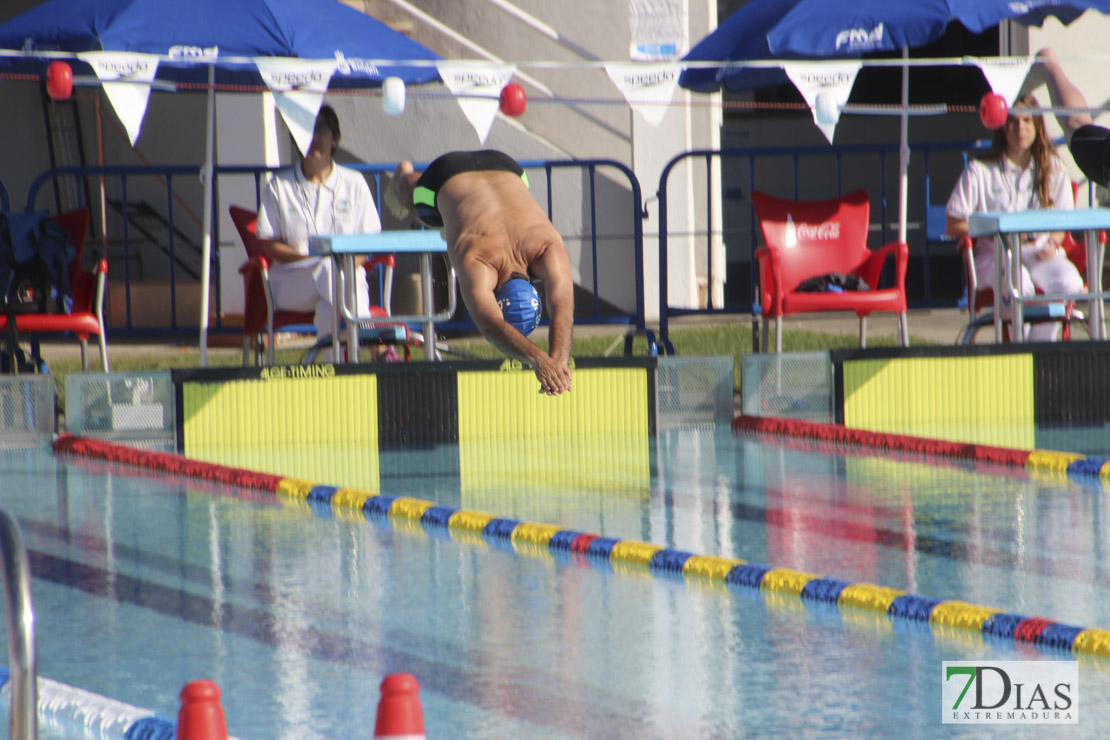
left=0, top=509, right=39, bottom=740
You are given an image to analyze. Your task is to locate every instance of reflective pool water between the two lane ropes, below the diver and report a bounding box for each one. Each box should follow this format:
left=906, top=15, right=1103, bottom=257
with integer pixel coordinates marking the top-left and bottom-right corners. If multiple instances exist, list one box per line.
left=186, top=421, right=1110, bottom=643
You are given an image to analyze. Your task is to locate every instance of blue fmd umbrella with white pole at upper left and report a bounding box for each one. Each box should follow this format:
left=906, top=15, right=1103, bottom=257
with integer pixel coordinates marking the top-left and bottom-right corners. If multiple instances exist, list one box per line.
left=0, top=0, right=440, bottom=366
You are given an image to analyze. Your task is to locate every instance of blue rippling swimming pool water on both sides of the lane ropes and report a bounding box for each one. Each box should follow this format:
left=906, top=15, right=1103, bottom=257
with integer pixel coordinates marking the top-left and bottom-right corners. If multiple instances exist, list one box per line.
left=0, top=430, right=1110, bottom=740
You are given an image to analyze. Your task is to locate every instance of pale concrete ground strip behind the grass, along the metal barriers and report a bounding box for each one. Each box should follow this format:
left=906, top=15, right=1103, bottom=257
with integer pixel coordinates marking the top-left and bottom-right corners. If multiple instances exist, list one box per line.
left=19, top=308, right=967, bottom=369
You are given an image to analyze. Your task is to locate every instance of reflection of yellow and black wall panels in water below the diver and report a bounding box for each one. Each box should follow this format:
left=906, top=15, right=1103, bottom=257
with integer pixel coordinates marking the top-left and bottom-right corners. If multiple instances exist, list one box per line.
left=190, top=435, right=652, bottom=530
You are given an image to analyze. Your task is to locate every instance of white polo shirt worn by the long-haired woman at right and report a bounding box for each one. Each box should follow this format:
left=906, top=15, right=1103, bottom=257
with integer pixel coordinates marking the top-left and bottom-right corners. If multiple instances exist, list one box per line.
left=947, top=156, right=1076, bottom=253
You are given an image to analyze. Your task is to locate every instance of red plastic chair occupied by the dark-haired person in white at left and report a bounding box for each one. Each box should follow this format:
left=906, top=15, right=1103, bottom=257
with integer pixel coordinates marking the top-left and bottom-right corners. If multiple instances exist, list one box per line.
left=229, top=205, right=410, bottom=365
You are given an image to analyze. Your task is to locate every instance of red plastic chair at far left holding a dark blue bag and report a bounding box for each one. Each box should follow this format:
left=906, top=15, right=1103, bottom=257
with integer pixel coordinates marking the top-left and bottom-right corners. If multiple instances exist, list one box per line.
left=0, top=207, right=108, bottom=373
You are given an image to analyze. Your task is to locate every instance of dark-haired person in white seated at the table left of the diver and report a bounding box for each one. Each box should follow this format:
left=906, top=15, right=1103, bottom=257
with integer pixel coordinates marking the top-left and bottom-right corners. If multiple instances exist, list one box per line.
left=258, top=105, right=382, bottom=359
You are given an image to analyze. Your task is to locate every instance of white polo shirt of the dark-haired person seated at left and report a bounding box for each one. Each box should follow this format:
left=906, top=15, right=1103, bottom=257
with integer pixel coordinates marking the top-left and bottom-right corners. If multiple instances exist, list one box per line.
left=258, top=164, right=382, bottom=270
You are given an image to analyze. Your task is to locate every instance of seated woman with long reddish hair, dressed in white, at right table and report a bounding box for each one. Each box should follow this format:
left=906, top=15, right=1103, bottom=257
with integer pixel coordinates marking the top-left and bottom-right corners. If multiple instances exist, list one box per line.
left=946, top=95, right=1083, bottom=342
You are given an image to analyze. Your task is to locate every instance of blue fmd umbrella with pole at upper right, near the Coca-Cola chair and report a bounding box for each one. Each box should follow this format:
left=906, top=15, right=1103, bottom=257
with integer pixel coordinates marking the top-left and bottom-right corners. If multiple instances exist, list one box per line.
left=678, top=0, right=1110, bottom=241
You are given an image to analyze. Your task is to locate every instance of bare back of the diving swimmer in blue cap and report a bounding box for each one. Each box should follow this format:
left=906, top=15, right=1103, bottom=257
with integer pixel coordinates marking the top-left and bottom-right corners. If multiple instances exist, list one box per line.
left=436, top=171, right=562, bottom=284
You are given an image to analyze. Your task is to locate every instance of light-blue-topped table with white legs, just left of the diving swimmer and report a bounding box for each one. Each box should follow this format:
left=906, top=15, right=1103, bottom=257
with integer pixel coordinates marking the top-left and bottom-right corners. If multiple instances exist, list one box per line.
left=309, top=231, right=456, bottom=363
